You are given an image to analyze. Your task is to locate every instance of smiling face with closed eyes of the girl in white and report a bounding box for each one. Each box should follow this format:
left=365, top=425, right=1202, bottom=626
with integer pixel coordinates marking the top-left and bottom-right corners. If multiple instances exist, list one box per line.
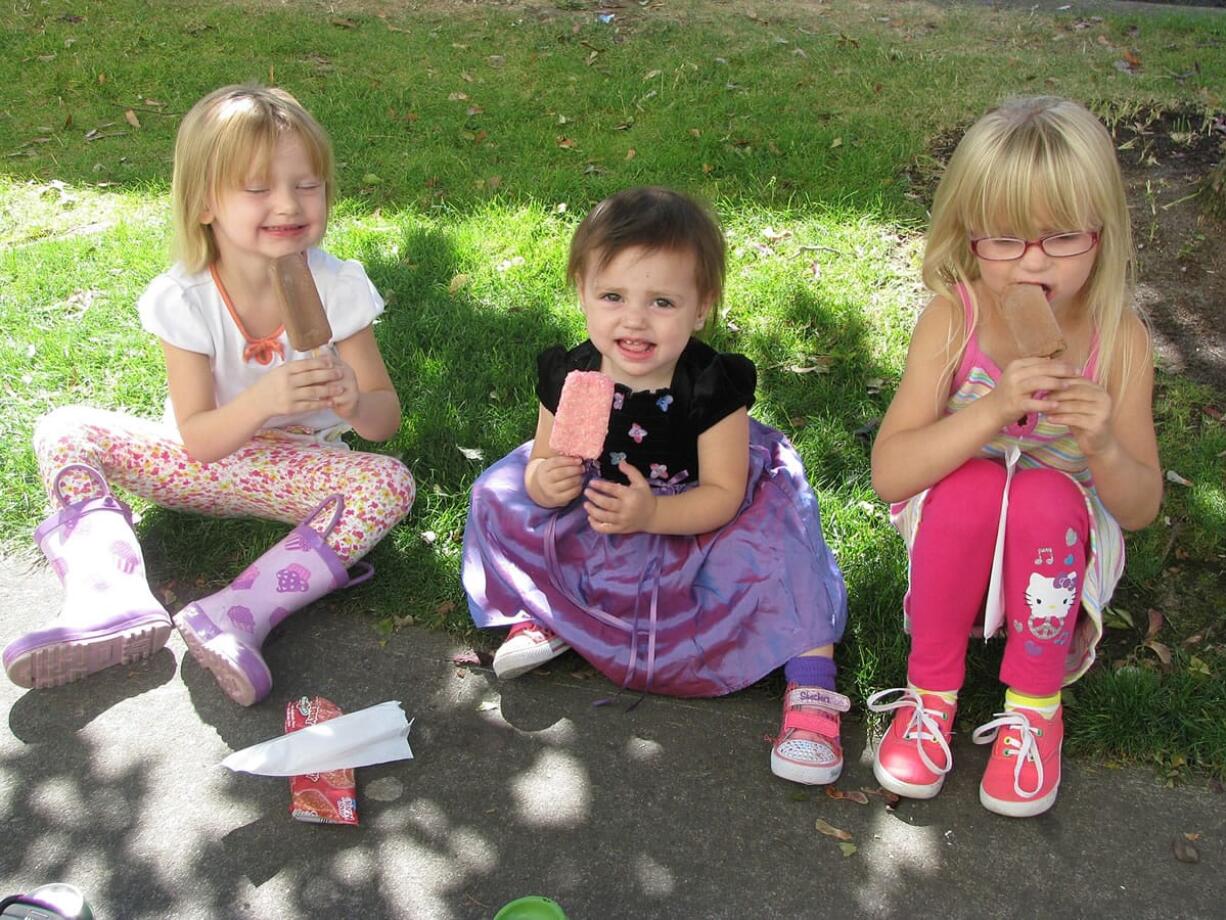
left=200, top=134, right=327, bottom=272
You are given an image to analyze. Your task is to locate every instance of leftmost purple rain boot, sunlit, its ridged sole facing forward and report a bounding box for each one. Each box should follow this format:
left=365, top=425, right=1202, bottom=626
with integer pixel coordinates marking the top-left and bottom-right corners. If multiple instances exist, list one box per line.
left=4, top=464, right=170, bottom=688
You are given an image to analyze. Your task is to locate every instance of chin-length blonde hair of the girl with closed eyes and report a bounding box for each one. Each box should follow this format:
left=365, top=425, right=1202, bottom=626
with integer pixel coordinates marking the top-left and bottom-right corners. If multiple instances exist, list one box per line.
left=170, top=85, right=333, bottom=271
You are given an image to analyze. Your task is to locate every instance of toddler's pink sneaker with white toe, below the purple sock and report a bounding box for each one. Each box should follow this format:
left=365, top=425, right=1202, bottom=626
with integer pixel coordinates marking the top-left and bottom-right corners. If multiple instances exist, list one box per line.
left=770, top=683, right=851, bottom=786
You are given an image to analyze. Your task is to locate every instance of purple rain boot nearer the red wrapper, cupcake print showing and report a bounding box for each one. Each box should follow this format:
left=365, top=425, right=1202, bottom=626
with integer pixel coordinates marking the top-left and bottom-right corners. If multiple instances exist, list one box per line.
left=175, top=496, right=374, bottom=707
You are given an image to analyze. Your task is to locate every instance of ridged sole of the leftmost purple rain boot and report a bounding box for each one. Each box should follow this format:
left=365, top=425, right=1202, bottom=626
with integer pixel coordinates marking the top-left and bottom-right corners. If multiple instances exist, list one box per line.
left=4, top=615, right=170, bottom=689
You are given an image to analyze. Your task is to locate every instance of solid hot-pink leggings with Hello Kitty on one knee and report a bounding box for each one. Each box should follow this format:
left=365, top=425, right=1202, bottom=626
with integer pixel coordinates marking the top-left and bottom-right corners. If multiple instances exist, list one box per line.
left=907, top=459, right=1090, bottom=696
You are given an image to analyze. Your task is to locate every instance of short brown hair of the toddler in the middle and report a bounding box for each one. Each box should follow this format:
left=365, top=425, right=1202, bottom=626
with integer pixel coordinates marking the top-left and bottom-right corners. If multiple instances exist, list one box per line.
left=566, top=186, right=725, bottom=310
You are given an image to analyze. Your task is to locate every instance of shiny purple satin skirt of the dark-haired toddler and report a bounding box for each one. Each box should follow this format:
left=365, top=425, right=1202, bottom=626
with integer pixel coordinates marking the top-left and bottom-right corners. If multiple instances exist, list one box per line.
left=462, top=420, right=847, bottom=697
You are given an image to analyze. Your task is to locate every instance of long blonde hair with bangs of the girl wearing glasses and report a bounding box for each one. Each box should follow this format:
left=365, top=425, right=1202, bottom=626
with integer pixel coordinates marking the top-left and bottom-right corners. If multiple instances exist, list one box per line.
left=923, top=96, right=1138, bottom=383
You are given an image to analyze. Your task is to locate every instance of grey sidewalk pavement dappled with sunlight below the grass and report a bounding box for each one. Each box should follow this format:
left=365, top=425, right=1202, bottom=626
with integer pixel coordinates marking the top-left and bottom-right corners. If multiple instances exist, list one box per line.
left=0, top=564, right=1226, bottom=920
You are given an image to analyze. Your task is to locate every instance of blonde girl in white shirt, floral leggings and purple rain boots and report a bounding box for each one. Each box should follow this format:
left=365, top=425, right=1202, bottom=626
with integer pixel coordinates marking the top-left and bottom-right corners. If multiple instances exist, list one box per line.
left=4, top=86, right=414, bottom=705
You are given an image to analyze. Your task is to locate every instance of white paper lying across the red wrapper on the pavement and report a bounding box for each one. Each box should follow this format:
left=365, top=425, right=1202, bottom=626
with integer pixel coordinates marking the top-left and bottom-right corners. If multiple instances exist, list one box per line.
left=222, top=700, right=413, bottom=776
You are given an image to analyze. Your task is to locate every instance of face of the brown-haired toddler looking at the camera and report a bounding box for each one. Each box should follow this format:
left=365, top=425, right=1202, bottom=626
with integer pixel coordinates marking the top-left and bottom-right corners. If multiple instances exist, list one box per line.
left=579, top=247, right=712, bottom=390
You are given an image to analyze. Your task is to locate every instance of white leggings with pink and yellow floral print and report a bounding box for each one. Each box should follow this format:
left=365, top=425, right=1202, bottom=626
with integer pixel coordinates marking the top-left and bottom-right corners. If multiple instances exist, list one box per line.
left=34, top=406, right=414, bottom=565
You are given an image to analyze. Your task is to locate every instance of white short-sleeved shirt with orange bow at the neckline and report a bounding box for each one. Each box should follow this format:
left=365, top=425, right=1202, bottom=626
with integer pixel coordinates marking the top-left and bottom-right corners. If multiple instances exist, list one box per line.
left=136, top=249, right=384, bottom=440
